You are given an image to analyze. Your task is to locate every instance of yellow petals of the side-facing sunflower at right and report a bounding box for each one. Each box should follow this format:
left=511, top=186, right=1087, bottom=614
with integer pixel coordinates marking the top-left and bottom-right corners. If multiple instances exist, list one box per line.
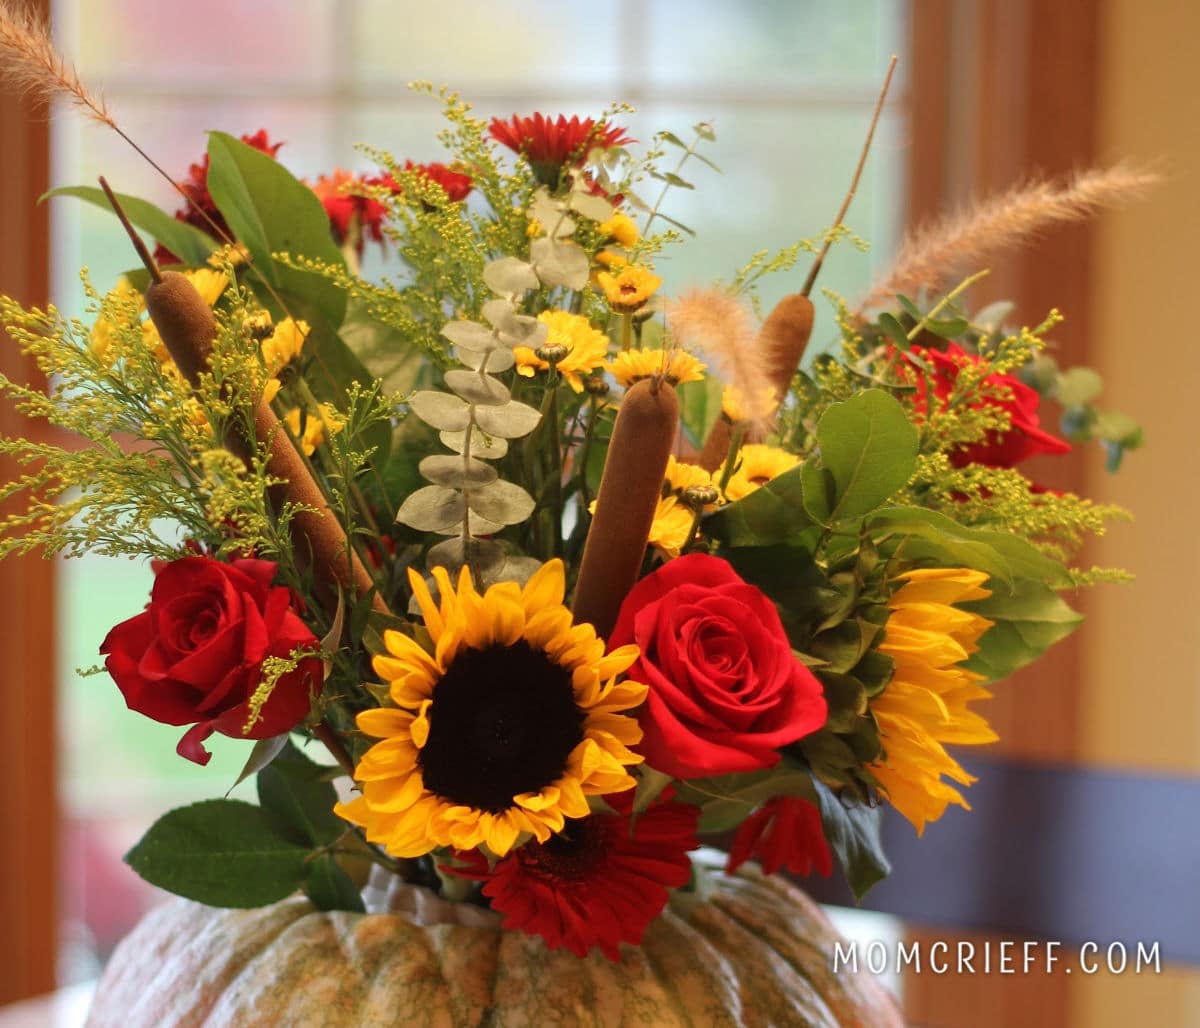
left=870, top=567, right=997, bottom=835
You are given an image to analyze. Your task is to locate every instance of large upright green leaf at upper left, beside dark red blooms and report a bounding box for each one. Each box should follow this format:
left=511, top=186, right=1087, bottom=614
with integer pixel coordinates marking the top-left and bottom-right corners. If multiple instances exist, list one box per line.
left=209, top=132, right=346, bottom=329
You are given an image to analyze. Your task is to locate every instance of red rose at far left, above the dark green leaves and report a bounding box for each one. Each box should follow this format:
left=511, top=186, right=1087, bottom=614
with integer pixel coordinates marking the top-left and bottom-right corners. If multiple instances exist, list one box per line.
left=100, top=557, right=322, bottom=764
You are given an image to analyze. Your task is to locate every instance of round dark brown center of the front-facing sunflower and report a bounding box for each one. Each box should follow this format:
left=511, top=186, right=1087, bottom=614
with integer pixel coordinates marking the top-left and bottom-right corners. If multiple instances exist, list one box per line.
left=420, top=639, right=584, bottom=813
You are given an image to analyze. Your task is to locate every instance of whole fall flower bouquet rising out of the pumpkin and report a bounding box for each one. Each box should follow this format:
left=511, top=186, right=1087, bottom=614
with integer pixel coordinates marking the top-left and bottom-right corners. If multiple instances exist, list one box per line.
left=0, top=23, right=1141, bottom=960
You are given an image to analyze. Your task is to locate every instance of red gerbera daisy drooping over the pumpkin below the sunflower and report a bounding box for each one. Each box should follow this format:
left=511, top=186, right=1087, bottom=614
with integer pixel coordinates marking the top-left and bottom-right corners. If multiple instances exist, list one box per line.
left=445, top=792, right=700, bottom=961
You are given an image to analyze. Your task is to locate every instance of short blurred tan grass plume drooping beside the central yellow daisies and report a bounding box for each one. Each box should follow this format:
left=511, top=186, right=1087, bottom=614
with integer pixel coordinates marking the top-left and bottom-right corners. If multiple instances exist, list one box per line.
left=667, top=287, right=780, bottom=434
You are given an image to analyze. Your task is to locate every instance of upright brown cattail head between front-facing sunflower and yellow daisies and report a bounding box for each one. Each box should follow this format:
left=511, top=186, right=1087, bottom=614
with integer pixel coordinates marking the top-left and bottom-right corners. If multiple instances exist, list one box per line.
left=572, top=378, right=679, bottom=638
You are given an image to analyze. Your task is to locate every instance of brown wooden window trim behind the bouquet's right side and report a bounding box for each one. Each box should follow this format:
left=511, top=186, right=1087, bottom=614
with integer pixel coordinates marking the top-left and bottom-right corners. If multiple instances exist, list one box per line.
left=904, top=0, right=1099, bottom=1028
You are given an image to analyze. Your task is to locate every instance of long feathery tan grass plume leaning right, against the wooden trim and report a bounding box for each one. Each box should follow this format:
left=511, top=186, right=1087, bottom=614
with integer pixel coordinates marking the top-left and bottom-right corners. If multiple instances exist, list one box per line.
left=858, top=164, right=1159, bottom=313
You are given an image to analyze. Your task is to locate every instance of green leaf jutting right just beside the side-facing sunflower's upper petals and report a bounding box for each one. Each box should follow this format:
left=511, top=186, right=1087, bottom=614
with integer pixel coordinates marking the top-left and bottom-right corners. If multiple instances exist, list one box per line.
left=964, top=578, right=1084, bottom=681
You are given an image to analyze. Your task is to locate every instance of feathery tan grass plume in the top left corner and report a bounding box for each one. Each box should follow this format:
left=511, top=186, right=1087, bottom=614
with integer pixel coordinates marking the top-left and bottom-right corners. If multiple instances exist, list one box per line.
left=0, top=0, right=116, bottom=128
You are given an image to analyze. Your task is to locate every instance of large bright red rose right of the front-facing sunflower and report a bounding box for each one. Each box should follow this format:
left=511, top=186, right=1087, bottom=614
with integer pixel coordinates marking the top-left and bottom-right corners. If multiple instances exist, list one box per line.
left=610, top=553, right=826, bottom=778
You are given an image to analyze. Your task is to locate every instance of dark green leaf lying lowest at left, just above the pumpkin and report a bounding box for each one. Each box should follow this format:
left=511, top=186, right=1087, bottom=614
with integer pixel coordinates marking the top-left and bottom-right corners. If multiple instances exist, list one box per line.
left=125, top=800, right=310, bottom=907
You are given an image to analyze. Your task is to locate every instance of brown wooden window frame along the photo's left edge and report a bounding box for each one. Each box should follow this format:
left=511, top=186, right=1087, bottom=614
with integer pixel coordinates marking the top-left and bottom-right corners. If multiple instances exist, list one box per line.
left=0, top=0, right=59, bottom=1004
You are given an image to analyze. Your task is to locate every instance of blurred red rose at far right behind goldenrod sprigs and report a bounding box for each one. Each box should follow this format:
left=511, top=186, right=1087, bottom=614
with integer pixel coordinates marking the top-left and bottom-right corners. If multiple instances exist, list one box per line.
left=912, top=343, right=1070, bottom=468
